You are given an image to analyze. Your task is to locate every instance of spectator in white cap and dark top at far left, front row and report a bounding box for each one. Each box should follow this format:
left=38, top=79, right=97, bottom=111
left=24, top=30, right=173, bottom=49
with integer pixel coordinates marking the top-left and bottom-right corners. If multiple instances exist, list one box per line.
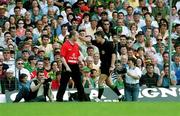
left=0, top=67, right=18, bottom=94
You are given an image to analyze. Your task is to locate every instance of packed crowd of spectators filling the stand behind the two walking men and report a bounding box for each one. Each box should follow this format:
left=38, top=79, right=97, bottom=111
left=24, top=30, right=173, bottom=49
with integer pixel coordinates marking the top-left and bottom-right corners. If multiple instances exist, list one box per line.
left=0, top=0, right=180, bottom=101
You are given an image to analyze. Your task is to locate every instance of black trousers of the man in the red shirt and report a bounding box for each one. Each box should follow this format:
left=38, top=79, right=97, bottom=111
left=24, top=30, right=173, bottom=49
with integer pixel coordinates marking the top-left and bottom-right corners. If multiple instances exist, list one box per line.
left=56, top=64, right=85, bottom=101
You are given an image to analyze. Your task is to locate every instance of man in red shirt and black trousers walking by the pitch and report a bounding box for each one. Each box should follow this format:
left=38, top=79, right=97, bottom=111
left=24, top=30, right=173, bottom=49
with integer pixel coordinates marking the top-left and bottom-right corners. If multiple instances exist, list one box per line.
left=56, top=31, right=85, bottom=102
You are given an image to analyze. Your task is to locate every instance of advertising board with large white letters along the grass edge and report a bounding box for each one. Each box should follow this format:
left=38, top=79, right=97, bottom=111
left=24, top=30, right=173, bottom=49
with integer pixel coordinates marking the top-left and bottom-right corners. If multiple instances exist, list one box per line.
left=0, top=86, right=180, bottom=103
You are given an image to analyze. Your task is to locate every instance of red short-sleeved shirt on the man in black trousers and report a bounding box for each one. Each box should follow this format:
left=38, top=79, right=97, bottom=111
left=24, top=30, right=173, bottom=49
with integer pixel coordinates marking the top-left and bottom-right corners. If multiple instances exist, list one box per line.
left=60, top=40, right=80, bottom=64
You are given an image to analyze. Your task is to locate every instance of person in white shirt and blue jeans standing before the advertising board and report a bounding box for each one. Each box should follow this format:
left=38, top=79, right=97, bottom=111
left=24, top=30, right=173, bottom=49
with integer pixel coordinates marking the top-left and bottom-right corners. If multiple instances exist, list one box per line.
left=125, top=58, right=142, bottom=101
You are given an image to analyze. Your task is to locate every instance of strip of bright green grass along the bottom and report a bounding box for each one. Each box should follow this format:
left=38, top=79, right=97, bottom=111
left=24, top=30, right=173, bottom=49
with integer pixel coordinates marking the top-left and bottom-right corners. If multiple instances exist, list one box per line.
left=0, top=102, right=180, bottom=116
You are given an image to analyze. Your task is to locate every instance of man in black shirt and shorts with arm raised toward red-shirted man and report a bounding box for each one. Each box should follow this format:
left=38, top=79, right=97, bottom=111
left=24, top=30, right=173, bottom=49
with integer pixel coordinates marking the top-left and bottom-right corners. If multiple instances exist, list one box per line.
left=91, top=31, right=122, bottom=102
